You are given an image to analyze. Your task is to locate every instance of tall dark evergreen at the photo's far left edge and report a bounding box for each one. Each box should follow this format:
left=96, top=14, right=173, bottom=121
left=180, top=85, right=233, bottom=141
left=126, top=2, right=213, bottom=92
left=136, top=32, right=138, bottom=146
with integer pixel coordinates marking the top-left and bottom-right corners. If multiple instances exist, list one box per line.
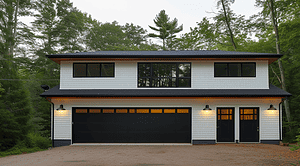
left=0, top=0, right=32, bottom=150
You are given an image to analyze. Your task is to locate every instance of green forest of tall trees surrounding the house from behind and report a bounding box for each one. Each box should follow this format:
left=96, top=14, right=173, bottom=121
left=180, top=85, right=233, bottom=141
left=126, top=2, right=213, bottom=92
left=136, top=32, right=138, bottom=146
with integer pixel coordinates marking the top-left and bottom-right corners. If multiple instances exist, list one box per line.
left=0, top=0, right=300, bottom=156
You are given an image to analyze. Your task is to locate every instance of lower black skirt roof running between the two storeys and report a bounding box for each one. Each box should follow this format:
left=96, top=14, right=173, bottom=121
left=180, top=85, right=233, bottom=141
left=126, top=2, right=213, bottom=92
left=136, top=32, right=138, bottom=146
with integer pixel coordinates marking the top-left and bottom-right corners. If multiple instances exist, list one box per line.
left=40, top=84, right=291, bottom=97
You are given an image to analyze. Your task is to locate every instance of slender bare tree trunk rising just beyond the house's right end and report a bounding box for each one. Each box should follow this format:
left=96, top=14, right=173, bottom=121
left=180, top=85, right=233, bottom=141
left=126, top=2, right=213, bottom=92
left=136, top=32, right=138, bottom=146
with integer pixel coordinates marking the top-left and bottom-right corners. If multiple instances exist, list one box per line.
left=267, top=0, right=291, bottom=131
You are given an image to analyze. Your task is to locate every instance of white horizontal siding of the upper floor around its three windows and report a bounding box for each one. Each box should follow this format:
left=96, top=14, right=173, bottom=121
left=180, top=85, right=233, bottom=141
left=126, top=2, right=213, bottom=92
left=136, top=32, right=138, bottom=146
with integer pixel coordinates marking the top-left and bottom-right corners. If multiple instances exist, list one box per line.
left=60, top=61, right=269, bottom=89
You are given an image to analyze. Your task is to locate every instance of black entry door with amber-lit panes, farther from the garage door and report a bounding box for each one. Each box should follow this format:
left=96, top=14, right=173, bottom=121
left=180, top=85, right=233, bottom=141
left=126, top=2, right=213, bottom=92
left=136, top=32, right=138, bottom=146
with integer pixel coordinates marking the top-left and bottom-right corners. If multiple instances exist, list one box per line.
left=240, top=108, right=259, bottom=142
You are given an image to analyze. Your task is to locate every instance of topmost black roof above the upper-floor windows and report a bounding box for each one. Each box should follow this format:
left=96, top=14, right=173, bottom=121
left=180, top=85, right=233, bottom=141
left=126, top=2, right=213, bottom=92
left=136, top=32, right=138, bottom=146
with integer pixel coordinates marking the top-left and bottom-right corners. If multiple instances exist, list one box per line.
left=46, top=50, right=282, bottom=58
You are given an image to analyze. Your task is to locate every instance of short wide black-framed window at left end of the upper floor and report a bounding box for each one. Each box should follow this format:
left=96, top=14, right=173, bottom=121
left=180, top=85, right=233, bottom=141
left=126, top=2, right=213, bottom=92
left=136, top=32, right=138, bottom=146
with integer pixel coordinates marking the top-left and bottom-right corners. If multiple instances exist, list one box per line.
left=73, top=63, right=115, bottom=77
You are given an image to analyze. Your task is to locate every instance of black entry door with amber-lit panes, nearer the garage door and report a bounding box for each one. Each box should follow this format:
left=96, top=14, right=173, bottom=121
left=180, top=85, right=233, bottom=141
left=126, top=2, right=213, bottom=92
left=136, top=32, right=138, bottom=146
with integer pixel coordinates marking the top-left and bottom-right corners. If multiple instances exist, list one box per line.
left=217, top=107, right=234, bottom=142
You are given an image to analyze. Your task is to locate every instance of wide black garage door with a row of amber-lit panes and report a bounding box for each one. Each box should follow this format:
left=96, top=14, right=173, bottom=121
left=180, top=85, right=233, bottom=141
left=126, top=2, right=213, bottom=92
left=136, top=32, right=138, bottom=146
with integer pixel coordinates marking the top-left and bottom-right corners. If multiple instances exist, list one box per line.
left=72, top=108, right=191, bottom=143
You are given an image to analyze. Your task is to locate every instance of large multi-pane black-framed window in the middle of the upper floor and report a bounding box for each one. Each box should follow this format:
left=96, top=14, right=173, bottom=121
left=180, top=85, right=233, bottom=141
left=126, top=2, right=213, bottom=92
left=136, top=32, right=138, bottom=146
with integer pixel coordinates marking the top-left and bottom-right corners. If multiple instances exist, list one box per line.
left=138, top=62, right=191, bottom=88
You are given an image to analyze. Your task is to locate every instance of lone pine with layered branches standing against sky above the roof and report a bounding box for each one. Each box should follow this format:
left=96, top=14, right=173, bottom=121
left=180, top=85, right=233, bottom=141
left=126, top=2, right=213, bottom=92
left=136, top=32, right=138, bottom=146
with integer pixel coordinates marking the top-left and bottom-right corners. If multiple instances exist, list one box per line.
left=149, top=10, right=183, bottom=50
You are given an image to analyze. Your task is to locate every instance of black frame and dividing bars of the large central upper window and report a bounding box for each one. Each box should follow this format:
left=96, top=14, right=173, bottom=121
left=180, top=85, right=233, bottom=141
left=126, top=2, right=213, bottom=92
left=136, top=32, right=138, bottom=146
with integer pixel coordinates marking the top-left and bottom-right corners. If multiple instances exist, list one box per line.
left=137, top=62, right=192, bottom=88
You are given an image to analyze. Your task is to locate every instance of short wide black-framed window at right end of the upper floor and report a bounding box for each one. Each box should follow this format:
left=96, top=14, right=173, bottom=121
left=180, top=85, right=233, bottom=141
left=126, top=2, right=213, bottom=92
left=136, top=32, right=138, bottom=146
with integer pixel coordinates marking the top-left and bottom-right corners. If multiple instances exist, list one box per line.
left=214, top=62, right=256, bottom=77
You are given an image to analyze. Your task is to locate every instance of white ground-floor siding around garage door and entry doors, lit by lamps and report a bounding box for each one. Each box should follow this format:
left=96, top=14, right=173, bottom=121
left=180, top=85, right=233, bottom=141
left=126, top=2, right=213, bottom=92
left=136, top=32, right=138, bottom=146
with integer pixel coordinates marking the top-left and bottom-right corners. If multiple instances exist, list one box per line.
left=53, top=98, right=280, bottom=140
